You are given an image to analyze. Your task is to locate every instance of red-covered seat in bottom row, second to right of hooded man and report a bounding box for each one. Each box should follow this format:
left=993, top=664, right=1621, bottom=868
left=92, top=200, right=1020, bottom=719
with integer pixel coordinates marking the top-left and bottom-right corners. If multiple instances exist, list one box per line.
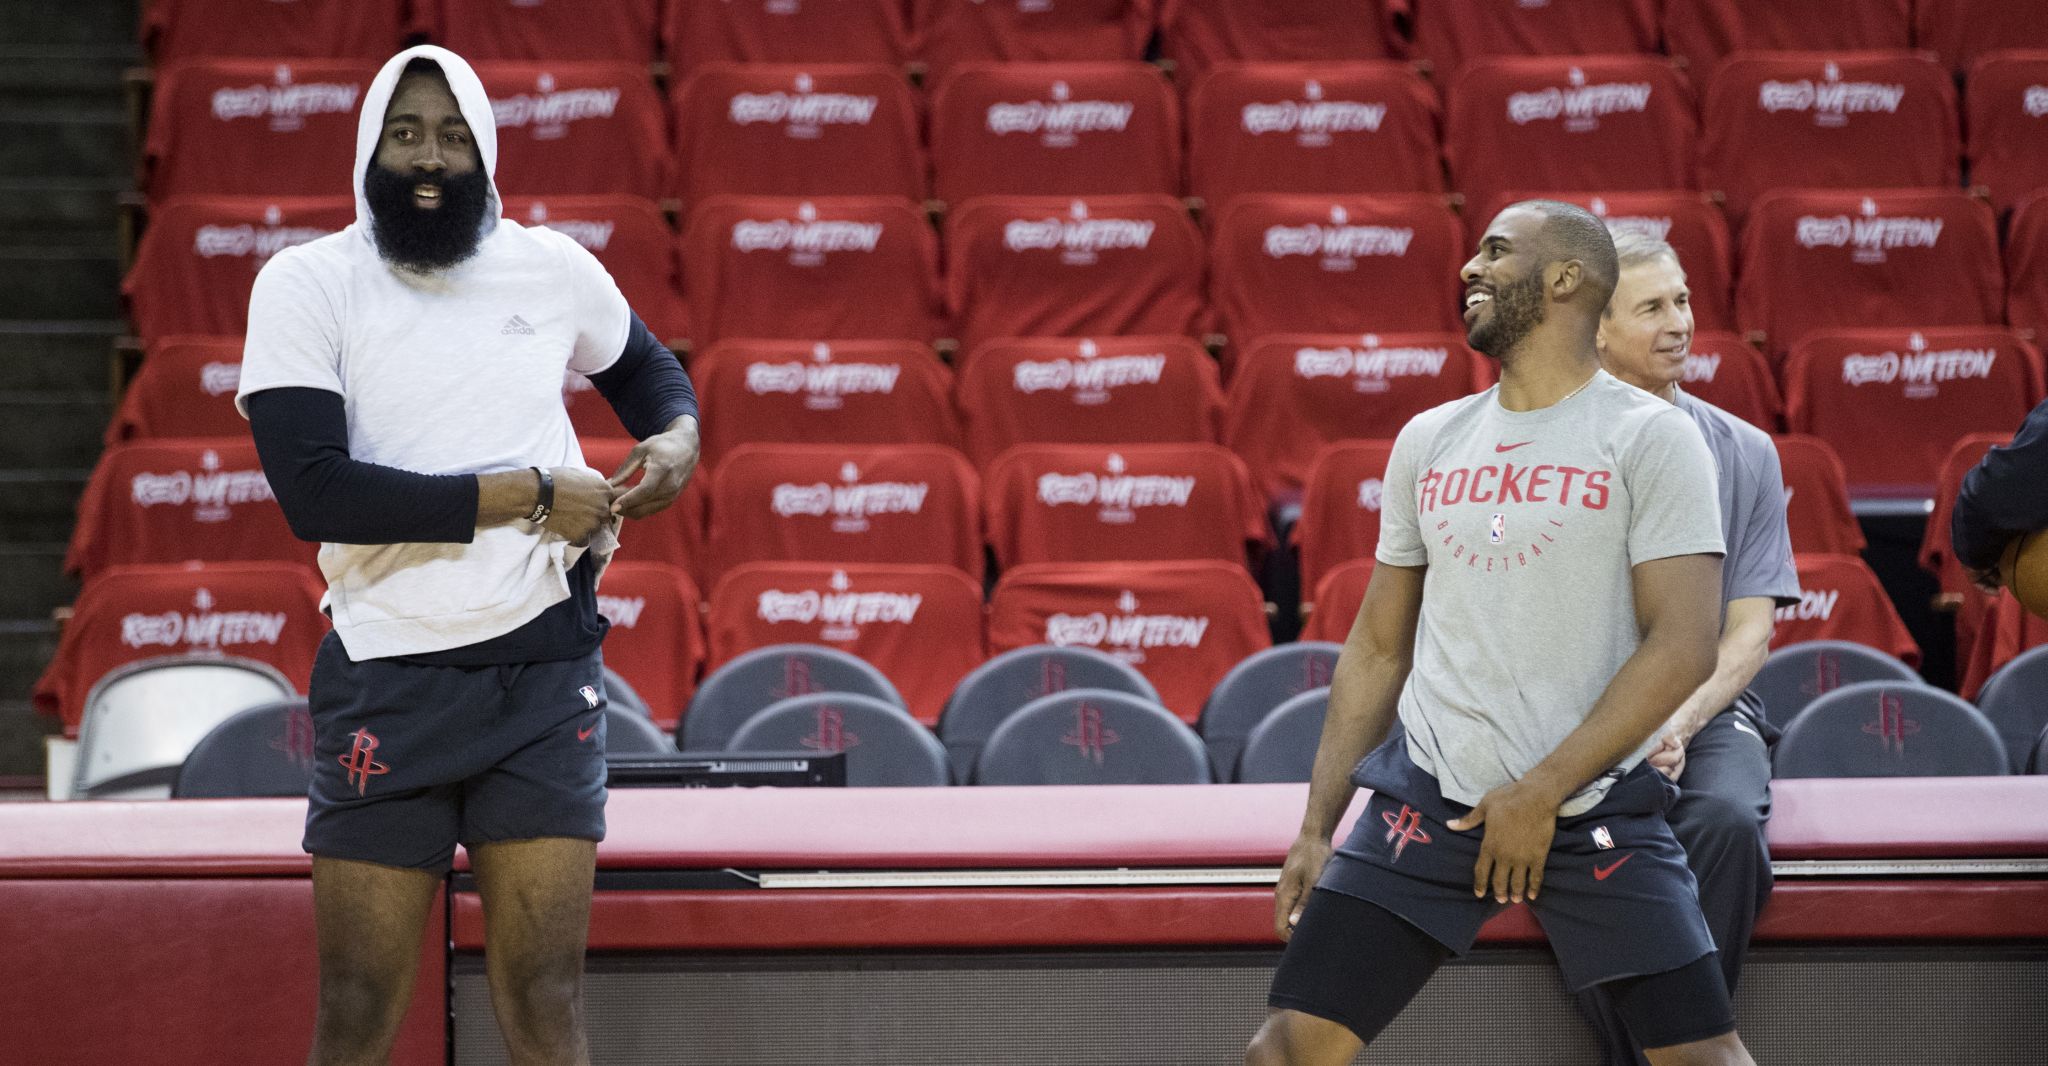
left=707, top=563, right=987, bottom=724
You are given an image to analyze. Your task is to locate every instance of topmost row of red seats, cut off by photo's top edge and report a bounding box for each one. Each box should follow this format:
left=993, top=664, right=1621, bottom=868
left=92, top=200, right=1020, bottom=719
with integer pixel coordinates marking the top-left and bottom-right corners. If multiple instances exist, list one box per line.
left=141, top=0, right=2048, bottom=72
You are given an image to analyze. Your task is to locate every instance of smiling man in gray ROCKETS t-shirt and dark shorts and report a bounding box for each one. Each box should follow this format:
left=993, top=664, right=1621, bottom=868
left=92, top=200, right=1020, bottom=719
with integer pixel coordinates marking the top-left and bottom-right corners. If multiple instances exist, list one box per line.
left=1245, top=201, right=1751, bottom=1066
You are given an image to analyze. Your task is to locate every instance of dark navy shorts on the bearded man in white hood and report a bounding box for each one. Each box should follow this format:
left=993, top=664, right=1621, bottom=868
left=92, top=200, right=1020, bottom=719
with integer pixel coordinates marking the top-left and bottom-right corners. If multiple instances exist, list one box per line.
left=305, top=632, right=604, bottom=872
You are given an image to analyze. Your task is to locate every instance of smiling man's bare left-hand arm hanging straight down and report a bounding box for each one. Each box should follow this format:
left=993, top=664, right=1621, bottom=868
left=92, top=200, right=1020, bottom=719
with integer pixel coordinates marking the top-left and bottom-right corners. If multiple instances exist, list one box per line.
left=1274, top=563, right=1425, bottom=937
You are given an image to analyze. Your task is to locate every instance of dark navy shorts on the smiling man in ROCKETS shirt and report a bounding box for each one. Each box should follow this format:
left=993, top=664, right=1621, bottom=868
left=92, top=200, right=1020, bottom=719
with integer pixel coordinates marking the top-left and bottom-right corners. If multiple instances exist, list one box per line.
left=1319, top=743, right=1714, bottom=990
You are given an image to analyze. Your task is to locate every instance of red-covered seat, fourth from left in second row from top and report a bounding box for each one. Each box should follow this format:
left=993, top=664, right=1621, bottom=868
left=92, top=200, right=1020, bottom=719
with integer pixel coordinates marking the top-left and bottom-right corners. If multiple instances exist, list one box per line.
left=932, top=62, right=1180, bottom=203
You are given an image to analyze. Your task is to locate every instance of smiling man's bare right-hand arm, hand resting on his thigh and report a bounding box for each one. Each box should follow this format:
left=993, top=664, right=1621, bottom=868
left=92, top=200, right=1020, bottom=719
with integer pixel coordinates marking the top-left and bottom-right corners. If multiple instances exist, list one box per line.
left=1446, top=554, right=1720, bottom=902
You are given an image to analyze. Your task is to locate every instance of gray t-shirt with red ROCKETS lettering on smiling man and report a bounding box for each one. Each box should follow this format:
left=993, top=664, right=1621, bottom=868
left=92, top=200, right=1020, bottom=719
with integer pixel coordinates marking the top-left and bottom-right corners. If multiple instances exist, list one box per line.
left=1378, top=370, right=1722, bottom=816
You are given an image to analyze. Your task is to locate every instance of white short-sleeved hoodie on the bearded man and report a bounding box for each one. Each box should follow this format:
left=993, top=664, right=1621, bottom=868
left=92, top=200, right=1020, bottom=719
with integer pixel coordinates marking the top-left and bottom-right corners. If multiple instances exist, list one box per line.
left=236, top=45, right=629, bottom=661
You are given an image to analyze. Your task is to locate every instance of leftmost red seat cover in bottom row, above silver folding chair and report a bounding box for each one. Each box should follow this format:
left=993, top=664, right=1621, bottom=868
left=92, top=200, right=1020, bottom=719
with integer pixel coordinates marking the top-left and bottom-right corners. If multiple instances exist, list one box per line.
left=35, top=563, right=328, bottom=737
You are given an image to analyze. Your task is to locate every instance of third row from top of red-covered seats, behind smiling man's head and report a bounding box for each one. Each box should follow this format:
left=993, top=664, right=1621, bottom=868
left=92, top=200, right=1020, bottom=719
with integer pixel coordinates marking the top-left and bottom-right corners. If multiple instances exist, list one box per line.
left=123, top=190, right=2048, bottom=353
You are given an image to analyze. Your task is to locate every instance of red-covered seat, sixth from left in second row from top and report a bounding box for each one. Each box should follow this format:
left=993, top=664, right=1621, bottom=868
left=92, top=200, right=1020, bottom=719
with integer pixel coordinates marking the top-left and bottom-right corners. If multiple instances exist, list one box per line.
left=1444, top=55, right=1698, bottom=221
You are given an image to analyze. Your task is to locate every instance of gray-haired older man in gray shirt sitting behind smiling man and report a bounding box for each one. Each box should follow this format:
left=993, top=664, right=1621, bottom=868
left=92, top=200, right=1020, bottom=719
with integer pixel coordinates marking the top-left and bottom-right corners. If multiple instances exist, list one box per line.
left=1579, top=233, right=1798, bottom=1066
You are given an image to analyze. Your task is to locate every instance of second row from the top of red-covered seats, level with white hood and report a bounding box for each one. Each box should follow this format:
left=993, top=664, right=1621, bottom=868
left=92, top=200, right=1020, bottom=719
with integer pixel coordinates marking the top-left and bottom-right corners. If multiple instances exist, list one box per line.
left=143, top=49, right=2048, bottom=219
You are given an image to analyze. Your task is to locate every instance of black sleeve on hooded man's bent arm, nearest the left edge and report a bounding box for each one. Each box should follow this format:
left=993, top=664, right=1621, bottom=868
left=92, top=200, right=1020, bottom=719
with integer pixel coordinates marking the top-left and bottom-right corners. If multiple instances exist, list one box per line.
left=248, top=389, right=477, bottom=544
